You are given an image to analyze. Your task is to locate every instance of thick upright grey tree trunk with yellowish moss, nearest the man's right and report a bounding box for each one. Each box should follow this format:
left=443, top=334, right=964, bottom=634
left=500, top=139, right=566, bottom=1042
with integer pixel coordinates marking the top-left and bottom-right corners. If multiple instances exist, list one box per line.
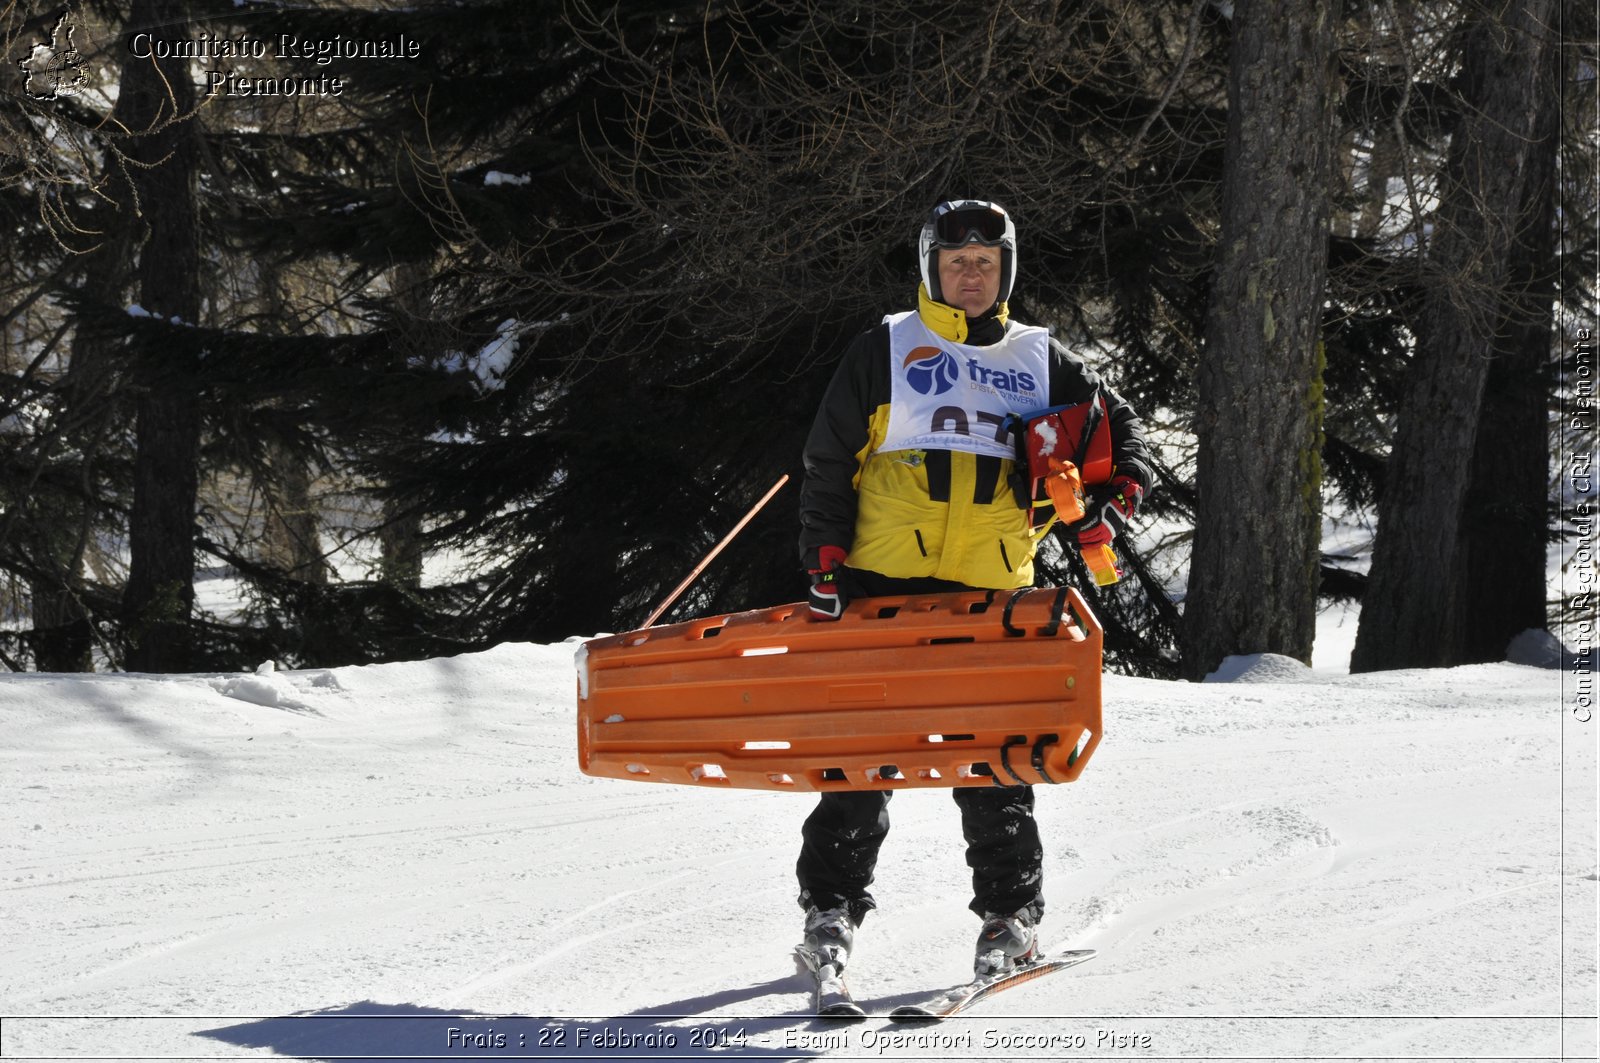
left=1182, top=0, right=1334, bottom=679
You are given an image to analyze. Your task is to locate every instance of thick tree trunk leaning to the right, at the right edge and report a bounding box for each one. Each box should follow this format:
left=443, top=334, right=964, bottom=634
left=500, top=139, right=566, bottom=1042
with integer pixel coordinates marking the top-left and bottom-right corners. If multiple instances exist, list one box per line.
left=1350, top=0, right=1554, bottom=671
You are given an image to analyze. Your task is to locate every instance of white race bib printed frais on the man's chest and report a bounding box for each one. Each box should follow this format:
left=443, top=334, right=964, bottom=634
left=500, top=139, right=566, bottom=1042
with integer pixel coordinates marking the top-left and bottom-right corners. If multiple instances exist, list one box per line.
left=878, top=311, right=1050, bottom=458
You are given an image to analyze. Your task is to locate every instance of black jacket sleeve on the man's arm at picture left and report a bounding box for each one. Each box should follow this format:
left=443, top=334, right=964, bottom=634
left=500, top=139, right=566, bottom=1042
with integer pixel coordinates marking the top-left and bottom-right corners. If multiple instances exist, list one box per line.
left=800, top=325, right=890, bottom=568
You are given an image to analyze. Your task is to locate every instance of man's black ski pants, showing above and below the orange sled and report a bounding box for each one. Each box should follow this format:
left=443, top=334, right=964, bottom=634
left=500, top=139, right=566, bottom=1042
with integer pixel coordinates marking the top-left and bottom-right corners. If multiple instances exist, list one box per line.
left=795, top=568, right=1045, bottom=924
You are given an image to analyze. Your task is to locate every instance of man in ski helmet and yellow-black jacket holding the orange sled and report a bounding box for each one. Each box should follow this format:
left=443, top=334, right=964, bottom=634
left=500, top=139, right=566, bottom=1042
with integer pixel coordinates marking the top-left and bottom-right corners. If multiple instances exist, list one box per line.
left=797, top=200, right=1154, bottom=977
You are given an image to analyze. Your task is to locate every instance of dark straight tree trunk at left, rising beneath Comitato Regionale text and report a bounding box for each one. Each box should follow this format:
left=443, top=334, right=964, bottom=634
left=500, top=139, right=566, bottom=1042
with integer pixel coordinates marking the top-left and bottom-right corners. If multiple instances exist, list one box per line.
left=118, top=0, right=200, bottom=672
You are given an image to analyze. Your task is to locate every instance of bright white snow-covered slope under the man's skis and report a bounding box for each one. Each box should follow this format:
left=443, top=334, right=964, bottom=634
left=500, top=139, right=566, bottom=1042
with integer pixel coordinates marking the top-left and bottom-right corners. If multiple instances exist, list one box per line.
left=0, top=615, right=1600, bottom=1060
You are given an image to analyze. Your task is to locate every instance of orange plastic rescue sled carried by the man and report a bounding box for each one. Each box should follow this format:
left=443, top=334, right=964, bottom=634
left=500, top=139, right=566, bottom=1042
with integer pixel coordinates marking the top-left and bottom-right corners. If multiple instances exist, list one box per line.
left=578, top=588, right=1101, bottom=791
